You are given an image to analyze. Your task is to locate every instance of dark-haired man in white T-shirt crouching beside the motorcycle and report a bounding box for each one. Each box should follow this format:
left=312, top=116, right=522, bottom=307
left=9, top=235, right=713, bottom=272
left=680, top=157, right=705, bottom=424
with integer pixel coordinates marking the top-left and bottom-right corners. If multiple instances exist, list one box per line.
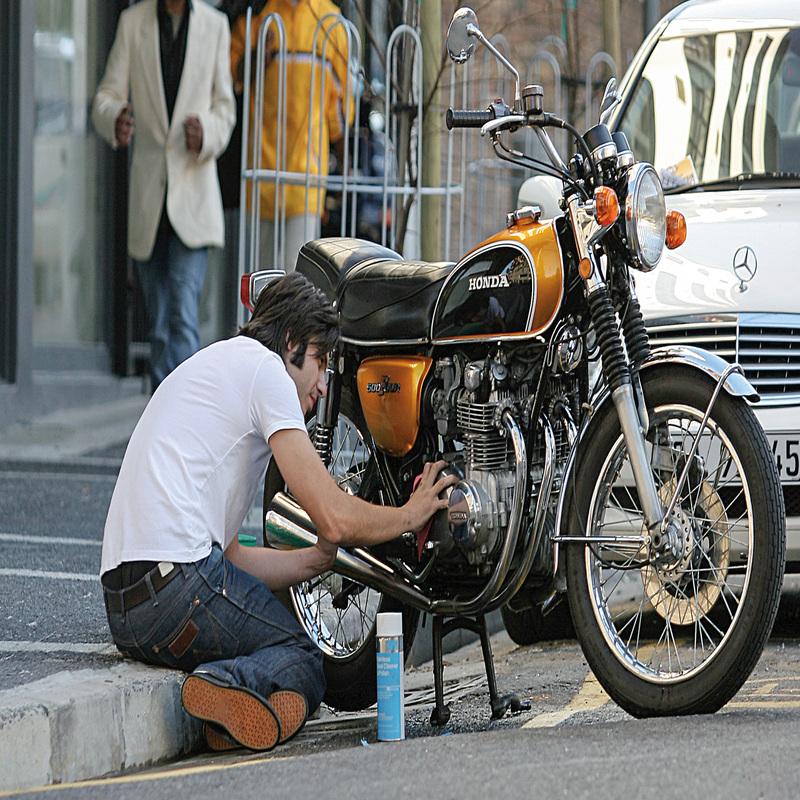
left=100, top=273, right=456, bottom=750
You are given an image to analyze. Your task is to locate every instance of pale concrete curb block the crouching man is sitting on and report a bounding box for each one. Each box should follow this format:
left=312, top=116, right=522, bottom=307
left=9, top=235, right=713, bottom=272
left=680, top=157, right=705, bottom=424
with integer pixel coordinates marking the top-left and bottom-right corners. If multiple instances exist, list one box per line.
left=0, top=663, right=202, bottom=791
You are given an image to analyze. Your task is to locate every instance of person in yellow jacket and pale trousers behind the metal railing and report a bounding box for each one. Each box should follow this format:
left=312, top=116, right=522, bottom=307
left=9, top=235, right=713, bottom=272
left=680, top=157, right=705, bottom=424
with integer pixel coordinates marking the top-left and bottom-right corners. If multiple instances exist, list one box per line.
left=231, top=0, right=355, bottom=272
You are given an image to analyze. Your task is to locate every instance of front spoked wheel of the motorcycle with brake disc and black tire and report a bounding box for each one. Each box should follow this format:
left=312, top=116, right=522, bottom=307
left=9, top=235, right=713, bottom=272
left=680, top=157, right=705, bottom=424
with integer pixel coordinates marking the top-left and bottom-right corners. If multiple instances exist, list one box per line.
left=566, top=366, right=786, bottom=717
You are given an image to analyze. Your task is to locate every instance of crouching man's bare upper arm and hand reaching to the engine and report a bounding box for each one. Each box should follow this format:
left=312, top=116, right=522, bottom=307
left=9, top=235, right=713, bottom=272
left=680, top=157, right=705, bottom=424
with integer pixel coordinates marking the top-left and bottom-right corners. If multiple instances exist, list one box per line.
left=269, top=429, right=458, bottom=545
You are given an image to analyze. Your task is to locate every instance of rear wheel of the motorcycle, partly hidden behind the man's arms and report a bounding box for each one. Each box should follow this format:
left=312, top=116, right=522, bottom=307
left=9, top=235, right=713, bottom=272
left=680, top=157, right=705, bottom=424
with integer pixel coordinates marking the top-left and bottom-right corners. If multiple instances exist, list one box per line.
left=264, top=389, right=419, bottom=711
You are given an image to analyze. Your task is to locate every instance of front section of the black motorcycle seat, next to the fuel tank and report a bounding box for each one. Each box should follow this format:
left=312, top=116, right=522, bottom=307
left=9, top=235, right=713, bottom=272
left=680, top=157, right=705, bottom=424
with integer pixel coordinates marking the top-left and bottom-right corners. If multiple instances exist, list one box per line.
left=337, top=259, right=454, bottom=342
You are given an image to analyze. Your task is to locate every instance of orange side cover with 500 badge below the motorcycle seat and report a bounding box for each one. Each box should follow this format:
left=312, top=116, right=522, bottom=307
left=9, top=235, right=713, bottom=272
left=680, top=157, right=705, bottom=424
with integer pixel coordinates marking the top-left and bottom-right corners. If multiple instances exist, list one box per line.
left=356, top=356, right=433, bottom=456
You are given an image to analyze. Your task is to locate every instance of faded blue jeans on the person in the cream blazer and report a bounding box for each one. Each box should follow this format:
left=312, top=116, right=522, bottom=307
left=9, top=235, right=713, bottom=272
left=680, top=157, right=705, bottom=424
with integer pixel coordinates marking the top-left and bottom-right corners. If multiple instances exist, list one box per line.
left=139, top=225, right=208, bottom=391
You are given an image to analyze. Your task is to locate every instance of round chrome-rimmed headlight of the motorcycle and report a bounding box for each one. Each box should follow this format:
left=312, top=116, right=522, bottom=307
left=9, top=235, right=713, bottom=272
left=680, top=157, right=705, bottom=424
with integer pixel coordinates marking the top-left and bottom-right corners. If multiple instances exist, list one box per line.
left=625, top=163, right=667, bottom=272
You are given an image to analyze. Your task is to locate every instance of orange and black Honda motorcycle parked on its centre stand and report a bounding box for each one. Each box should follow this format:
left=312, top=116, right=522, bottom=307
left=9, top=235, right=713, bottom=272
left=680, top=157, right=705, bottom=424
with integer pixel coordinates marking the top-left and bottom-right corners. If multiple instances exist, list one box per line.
left=242, top=8, right=785, bottom=725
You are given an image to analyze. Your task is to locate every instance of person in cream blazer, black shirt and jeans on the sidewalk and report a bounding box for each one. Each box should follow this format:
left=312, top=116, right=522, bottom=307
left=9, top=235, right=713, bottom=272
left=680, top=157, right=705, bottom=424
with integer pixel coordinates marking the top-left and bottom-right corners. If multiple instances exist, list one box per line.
left=92, top=0, right=236, bottom=391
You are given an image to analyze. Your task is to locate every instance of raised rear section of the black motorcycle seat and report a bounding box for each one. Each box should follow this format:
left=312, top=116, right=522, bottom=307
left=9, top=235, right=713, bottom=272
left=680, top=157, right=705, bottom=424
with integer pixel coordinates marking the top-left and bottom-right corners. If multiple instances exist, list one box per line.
left=296, top=237, right=402, bottom=302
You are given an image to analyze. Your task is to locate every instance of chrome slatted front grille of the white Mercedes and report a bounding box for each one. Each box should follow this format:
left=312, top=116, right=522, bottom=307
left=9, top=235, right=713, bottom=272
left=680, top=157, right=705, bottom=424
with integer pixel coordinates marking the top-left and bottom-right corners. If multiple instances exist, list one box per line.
left=647, top=314, right=800, bottom=405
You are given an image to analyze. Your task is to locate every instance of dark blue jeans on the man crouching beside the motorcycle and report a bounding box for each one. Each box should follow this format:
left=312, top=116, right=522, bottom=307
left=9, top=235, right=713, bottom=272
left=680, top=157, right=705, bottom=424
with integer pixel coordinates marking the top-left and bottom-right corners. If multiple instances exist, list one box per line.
left=108, top=546, right=325, bottom=712
